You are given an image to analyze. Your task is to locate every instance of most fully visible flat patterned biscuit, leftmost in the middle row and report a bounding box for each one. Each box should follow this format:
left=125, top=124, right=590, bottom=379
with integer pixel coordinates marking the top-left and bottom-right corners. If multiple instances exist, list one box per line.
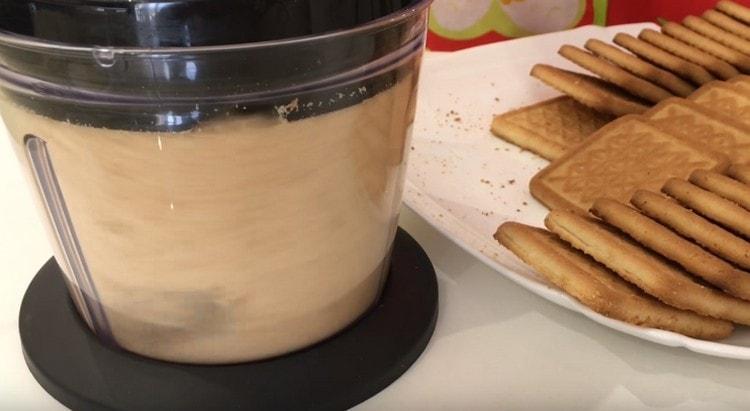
left=530, top=116, right=729, bottom=214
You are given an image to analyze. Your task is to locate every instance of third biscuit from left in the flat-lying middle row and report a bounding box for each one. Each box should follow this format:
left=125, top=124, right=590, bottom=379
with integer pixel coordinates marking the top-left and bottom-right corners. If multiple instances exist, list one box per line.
left=688, top=81, right=750, bottom=125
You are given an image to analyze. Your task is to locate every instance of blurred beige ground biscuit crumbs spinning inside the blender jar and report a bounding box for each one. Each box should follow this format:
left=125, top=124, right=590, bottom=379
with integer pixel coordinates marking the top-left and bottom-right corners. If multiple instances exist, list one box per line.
left=0, top=76, right=416, bottom=363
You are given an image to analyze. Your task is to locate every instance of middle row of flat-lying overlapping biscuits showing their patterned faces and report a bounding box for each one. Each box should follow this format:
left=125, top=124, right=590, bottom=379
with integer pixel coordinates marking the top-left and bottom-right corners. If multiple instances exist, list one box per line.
left=530, top=76, right=750, bottom=214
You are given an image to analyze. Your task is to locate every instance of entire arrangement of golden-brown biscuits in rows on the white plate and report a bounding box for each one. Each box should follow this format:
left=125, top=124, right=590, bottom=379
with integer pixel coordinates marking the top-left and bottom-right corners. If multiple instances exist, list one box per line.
left=492, top=1, right=750, bottom=340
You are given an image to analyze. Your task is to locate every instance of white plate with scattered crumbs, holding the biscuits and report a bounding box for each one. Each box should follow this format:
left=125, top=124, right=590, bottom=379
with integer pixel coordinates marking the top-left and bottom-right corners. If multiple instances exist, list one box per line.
left=404, top=23, right=750, bottom=360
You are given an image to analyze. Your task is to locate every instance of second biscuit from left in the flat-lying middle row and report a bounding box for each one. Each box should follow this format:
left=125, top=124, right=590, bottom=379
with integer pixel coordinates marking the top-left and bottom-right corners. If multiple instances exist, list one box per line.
left=643, top=98, right=750, bottom=163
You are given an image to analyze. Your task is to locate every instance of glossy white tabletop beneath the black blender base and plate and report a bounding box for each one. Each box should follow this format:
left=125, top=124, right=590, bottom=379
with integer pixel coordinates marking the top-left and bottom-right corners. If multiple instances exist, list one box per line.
left=0, top=120, right=750, bottom=411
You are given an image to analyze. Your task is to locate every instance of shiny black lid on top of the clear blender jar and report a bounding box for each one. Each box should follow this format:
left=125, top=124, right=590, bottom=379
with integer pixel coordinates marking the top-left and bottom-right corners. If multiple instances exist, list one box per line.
left=0, top=0, right=415, bottom=47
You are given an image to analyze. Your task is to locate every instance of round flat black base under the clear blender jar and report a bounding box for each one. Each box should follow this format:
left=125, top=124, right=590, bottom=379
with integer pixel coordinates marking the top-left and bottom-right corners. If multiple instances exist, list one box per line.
left=20, top=229, right=438, bottom=410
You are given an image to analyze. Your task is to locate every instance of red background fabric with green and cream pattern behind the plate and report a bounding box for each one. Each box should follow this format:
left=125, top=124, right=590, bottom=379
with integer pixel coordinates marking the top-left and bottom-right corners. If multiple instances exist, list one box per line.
left=427, top=0, right=750, bottom=51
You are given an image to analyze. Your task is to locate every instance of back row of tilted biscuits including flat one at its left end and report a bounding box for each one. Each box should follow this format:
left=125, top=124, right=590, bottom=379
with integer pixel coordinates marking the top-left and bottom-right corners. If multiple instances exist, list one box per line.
left=492, top=0, right=750, bottom=160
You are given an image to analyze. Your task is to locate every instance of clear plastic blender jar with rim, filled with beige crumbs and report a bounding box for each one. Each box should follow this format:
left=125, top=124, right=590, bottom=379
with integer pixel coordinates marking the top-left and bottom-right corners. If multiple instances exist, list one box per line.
left=0, top=1, right=428, bottom=364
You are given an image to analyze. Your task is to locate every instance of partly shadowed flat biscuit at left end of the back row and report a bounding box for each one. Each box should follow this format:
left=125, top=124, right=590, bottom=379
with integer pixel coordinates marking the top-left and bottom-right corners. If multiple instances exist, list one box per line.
left=492, top=96, right=613, bottom=161
